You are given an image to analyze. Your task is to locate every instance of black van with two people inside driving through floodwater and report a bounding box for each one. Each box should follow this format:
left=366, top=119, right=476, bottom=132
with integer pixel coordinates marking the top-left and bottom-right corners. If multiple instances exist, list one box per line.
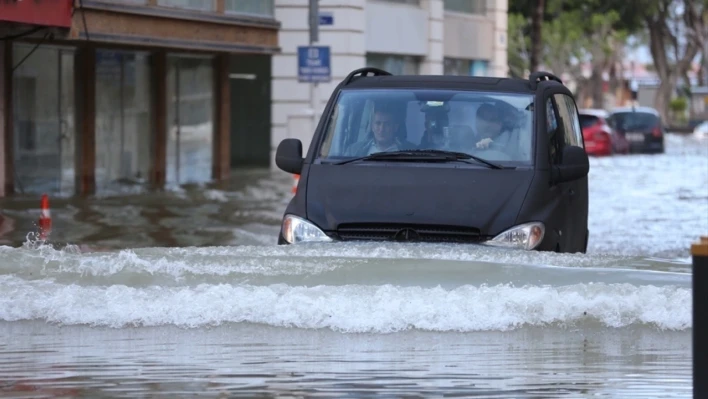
left=275, top=68, right=589, bottom=253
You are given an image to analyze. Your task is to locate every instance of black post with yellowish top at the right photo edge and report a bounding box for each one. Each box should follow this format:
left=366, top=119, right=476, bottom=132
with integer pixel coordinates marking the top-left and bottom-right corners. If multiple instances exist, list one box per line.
left=691, top=236, right=708, bottom=399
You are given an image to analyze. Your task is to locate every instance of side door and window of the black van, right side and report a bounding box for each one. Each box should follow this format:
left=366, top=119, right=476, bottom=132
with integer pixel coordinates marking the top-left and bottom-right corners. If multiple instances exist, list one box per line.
left=551, top=93, right=588, bottom=252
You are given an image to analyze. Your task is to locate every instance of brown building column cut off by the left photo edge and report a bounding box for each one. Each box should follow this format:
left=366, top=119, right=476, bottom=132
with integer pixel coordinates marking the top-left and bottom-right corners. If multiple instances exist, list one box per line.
left=0, top=40, right=15, bottom=197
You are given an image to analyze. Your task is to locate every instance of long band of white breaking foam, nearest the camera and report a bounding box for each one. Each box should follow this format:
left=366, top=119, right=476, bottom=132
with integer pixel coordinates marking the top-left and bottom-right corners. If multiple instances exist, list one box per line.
left=0, top=276, right=692, bottom=333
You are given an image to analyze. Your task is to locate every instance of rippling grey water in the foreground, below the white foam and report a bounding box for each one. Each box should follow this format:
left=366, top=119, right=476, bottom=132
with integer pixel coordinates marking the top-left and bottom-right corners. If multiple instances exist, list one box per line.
left=0, top=323, right=692, bottom=398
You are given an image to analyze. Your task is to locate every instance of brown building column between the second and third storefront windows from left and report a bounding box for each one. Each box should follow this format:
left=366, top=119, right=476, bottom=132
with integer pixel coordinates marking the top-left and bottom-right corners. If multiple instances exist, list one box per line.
left=150, top=50, right=168, bottom=188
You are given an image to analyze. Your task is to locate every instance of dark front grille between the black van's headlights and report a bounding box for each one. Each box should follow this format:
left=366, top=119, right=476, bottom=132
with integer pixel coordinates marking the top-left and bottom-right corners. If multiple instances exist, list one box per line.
left=337, top=223, right=487, bottom=243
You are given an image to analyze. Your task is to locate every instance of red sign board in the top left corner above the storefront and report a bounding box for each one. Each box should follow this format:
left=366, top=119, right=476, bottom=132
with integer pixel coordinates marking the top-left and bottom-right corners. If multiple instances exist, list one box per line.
left=0, top=0, right=74, bottom=28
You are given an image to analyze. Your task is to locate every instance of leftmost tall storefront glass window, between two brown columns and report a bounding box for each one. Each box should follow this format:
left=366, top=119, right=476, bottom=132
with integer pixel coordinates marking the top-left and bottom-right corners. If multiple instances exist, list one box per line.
left=12, top=44, right=76, bottom=195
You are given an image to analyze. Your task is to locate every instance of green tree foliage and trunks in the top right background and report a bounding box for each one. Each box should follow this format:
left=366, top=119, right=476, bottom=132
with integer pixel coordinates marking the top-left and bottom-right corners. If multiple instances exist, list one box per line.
left=508, top=0, right=708, bottom=117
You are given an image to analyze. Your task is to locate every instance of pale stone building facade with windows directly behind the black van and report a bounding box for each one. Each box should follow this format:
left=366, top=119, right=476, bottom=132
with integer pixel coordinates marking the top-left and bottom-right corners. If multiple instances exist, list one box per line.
left=271, top=0, right=508, bottom=167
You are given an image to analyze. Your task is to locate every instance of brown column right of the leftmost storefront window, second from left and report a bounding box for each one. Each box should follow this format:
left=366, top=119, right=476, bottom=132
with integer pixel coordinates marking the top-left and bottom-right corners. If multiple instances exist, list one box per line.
left=74, top=45, right=96, bottom=195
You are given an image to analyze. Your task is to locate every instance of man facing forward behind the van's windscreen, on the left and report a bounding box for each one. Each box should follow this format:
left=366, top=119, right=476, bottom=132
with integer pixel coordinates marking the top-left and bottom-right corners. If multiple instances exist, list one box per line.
left=347, top=106, right=416, bottom=156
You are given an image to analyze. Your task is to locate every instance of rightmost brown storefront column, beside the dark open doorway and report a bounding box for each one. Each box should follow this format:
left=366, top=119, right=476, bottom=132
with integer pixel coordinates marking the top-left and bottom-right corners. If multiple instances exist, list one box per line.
left=211, top=54, right=231, bottom=180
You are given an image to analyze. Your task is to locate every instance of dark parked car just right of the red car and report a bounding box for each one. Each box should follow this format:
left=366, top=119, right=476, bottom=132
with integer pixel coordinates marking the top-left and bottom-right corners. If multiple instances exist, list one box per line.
left=607, top=107, right=666, bottom=154
